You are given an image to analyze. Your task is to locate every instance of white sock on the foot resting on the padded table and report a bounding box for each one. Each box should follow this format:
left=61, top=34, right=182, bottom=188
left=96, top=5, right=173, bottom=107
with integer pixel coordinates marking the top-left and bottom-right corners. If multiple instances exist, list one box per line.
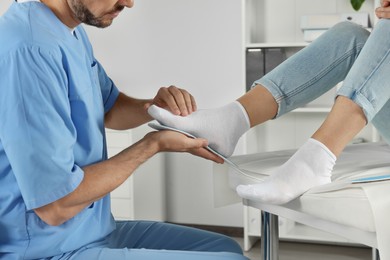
left=237, top=138, right=336, bottom=204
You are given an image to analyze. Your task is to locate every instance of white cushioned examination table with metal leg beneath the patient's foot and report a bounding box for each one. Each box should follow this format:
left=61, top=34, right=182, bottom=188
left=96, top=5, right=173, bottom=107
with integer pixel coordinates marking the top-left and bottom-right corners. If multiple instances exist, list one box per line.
left=214, top=143, right=390, bottom=260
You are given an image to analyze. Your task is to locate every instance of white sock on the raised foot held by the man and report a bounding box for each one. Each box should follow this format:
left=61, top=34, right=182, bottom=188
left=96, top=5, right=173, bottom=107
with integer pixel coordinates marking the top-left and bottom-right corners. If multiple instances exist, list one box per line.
left=148, top=101, right=250, bottom=157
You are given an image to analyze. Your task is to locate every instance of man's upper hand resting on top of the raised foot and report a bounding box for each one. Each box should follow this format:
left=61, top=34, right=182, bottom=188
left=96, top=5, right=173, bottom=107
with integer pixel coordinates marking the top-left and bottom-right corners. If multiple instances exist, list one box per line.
left=146, top=86, right=196, bottom=116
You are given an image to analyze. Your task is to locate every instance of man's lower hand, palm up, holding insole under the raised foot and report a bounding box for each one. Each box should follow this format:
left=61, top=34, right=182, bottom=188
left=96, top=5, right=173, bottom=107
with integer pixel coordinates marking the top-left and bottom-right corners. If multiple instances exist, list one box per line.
left=145, top=130, right=224, bottom=163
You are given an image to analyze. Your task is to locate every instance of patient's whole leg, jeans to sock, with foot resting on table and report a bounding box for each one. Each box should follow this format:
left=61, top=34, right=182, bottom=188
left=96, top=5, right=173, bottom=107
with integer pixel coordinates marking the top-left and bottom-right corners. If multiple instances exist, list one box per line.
left=237, top=20, right=390, bottom=204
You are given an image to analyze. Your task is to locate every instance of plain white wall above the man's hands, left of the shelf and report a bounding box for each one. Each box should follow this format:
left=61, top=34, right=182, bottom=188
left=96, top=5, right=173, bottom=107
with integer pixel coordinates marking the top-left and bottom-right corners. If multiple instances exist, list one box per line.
left=88, top=0, right=242, bottom=107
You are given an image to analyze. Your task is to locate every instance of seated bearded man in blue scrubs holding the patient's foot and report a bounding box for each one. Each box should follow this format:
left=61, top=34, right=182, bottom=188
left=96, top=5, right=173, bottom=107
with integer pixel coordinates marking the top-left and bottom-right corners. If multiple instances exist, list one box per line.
left=0, top=0, right=246, bottom=260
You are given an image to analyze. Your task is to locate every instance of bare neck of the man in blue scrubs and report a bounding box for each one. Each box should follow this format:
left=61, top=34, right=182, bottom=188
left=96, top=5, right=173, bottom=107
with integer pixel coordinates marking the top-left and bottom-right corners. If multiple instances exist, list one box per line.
left=40, top=0, right=81, bottom=29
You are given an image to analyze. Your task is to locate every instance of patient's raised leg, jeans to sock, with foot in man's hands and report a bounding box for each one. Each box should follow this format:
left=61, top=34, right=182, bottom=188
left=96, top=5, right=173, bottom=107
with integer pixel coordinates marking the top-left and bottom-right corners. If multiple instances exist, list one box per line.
left=149, top=22, right=368, bottom=157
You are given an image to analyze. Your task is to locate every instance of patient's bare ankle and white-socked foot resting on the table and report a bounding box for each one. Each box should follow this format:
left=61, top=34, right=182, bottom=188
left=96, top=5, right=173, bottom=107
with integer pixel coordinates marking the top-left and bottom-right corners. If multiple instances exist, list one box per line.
left=237, top=96, right=366, bottom=204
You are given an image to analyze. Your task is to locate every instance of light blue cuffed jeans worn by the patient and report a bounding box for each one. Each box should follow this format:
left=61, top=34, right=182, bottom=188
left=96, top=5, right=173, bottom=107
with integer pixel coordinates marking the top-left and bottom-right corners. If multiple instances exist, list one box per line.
left=255, top=19, right=390, bottom=142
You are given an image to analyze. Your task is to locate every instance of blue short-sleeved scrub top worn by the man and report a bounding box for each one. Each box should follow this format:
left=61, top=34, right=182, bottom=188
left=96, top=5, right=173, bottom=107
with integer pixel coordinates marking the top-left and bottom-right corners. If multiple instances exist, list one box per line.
left=0, top=2, right=119, bottom=259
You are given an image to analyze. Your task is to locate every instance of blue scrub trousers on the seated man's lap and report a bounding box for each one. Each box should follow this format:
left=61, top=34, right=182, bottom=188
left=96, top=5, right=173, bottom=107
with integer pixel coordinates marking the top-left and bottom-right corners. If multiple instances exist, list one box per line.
left=66, top=221, right=248, bottom=260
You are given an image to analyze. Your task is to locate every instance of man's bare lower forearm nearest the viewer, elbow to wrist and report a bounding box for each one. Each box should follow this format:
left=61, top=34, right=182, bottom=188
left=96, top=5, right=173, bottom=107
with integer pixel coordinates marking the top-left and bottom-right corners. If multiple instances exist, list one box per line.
left=35, top=135, right=158, bottom=225
